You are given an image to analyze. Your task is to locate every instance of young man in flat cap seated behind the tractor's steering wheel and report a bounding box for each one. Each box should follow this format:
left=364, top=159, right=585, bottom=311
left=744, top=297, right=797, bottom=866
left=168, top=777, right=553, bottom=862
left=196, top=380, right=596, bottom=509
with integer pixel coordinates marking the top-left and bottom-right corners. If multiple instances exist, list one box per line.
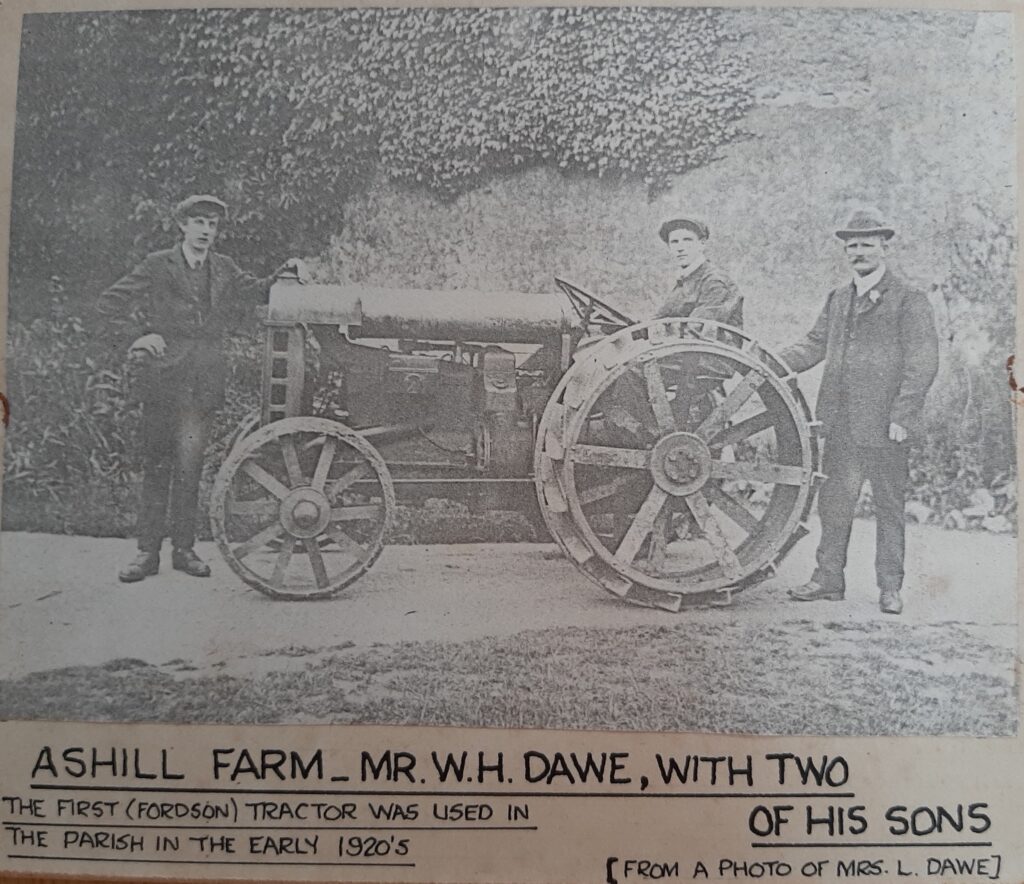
left=655, top=217, right=743, bottom=328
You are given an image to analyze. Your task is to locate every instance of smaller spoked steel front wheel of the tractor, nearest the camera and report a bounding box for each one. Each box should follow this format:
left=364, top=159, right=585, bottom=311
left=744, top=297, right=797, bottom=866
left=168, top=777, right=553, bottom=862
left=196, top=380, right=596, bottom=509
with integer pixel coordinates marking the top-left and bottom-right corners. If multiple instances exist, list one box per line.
left=210, top=417, right=395, bottom=599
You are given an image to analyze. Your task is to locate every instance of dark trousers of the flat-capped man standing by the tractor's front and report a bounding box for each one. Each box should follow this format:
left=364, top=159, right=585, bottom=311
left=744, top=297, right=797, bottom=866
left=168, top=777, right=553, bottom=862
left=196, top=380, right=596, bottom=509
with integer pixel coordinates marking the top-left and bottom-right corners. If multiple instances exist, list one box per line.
left=138, top=394, right=210, bottom=552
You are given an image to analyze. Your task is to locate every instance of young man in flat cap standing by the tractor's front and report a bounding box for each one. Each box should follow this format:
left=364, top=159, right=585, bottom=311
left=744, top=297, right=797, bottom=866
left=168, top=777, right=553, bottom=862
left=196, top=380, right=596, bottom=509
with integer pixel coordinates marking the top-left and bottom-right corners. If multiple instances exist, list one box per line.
left=99, top=194, right=304, bottom=583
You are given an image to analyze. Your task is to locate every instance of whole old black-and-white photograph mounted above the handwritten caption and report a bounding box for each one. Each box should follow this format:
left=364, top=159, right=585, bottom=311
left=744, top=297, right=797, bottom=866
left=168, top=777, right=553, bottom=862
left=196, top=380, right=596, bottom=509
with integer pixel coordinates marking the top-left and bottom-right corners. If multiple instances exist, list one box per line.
left=0, top=6, right=1024, bottom=737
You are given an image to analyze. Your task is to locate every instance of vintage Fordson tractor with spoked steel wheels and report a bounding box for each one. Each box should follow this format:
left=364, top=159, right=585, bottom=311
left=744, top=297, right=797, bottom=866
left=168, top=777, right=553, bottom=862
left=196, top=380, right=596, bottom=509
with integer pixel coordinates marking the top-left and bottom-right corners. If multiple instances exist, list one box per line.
left=211, top=280, right=819, bottom=611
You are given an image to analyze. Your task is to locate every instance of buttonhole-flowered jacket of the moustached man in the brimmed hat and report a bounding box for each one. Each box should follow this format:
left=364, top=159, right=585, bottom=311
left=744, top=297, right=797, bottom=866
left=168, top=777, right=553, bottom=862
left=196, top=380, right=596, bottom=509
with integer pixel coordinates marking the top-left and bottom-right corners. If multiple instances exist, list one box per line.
left=779, top=269, right=939, bottom=446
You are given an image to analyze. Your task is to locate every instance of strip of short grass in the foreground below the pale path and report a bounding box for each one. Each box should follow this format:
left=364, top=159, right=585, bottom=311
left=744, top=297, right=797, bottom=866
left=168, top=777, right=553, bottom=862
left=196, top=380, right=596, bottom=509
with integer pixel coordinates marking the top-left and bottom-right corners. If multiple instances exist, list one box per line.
left=0, top=621, right=1017, bottom=735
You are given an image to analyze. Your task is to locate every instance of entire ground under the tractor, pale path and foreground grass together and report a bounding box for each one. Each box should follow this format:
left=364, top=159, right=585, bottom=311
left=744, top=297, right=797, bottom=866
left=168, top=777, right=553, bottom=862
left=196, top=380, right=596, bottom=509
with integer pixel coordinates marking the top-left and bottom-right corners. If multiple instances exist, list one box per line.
left=0, top=521, right=1017, bottom=733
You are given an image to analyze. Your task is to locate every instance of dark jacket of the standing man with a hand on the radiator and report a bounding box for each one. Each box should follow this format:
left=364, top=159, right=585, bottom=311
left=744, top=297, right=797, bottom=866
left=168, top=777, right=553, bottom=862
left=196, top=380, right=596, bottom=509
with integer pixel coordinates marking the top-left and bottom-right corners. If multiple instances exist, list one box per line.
left=99, top=245, right=274, bottom=411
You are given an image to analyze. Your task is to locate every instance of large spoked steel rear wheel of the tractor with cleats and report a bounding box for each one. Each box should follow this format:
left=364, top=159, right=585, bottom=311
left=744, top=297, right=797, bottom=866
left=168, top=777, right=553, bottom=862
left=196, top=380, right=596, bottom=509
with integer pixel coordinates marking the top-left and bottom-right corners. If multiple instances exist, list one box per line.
left=535, top=320, right=818, bottom=609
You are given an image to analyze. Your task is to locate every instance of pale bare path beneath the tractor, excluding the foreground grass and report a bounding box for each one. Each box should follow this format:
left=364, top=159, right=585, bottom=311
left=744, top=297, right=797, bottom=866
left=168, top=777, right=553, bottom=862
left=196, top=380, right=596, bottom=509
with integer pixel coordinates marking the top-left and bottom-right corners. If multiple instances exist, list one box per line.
left=0, top=521, right=1017, bottom=679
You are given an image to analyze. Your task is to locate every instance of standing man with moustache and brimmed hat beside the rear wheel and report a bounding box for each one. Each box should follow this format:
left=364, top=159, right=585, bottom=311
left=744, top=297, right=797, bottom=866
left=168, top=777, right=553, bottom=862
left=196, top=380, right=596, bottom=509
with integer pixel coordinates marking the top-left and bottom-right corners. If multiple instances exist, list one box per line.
left=779, top=209, right=938, bottom=614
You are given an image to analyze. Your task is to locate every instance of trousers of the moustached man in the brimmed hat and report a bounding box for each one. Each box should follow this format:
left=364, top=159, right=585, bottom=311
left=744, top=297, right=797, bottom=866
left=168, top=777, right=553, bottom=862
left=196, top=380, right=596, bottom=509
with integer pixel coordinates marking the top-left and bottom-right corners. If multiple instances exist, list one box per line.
left=813, top=433, right=908, bottom=592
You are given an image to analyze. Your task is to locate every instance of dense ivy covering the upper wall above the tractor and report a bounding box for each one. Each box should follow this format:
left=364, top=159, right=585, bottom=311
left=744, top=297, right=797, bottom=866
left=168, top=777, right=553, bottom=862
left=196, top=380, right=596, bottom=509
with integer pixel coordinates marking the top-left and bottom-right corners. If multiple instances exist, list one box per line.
left=11, top=8, right=752, bottom=309
